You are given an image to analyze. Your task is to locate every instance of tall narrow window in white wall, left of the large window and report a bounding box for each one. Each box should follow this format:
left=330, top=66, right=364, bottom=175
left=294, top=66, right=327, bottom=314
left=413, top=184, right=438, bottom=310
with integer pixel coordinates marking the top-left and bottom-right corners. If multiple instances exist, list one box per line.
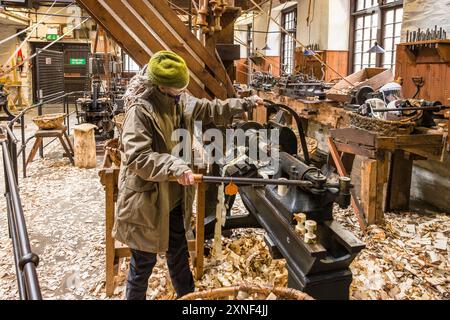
left=281, top=8, right=297, bottom=74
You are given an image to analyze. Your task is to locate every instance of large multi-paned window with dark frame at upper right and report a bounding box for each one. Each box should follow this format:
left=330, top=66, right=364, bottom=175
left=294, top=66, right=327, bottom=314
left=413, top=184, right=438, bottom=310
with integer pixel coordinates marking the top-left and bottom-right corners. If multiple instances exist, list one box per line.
left=352, top=0, right=403, bottom=72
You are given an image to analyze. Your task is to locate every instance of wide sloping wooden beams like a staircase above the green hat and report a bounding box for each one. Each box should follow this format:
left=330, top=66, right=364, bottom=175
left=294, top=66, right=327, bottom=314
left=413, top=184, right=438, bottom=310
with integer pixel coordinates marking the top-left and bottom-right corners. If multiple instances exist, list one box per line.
left=77, top=0, right=235, bottom=99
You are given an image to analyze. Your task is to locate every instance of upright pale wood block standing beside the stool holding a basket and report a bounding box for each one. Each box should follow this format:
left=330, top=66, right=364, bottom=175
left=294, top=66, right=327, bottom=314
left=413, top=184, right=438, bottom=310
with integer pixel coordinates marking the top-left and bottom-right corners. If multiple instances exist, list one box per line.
left=74, top=123, right=97, bottom=169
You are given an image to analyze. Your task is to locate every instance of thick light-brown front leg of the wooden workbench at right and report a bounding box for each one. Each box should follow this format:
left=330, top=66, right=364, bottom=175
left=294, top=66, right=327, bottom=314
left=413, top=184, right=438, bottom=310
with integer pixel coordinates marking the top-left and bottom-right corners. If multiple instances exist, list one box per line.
left=361, top=153, right=389, bottom=225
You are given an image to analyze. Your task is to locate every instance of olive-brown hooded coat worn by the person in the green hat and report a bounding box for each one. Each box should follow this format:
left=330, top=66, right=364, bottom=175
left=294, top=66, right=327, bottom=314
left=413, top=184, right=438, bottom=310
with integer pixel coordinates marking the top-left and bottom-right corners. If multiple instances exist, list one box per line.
left=113, top=76, right=254, bottom=253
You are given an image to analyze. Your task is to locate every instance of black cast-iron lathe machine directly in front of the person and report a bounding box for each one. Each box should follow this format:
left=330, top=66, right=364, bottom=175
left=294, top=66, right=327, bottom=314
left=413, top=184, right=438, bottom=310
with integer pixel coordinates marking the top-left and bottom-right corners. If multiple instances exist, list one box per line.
left=206, top=104, right=364, bottom=299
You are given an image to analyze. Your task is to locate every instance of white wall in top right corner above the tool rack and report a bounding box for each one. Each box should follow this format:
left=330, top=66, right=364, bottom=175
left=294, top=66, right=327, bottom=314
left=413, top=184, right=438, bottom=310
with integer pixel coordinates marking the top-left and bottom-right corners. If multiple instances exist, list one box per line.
left=402, top=0, right=450, bottom=41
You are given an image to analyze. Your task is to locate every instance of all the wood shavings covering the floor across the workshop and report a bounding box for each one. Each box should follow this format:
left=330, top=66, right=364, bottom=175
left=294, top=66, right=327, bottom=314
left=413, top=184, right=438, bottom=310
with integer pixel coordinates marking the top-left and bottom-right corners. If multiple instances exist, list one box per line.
left=0, top=149, right=450, bottom=300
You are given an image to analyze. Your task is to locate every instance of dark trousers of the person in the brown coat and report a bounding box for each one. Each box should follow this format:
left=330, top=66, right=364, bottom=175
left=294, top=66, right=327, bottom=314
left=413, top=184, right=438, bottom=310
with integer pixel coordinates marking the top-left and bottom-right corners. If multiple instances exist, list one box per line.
left=126, top=206, right=195, bottom=300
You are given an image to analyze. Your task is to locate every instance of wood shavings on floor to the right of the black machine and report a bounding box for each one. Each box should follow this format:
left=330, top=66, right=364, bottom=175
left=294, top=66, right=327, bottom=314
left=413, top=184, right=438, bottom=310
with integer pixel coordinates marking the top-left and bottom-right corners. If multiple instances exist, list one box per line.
left=335, top=205, right=450, bottom=300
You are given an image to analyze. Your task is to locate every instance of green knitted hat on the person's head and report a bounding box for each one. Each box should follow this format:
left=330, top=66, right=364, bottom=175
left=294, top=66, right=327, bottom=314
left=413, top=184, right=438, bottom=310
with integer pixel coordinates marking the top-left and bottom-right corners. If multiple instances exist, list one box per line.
left=147, top=51, right=189, bottom=89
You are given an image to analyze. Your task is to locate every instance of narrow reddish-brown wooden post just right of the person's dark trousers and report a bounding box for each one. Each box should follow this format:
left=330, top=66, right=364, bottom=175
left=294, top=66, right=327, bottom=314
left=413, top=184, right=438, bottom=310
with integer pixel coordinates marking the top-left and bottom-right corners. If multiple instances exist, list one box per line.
left=195, top=182, right=206, bottom=280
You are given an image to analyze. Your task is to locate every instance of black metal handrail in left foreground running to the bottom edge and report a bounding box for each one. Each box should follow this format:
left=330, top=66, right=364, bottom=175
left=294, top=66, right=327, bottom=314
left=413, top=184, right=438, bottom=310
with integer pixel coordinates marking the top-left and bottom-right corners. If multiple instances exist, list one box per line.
left=0, top=126, right=42, bottom=300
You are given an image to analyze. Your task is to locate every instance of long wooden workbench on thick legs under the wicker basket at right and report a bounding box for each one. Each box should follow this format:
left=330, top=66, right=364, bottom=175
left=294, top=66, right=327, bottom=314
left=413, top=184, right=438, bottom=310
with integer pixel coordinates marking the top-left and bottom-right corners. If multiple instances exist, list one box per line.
left=254, top=92, right=448, bottom=224
